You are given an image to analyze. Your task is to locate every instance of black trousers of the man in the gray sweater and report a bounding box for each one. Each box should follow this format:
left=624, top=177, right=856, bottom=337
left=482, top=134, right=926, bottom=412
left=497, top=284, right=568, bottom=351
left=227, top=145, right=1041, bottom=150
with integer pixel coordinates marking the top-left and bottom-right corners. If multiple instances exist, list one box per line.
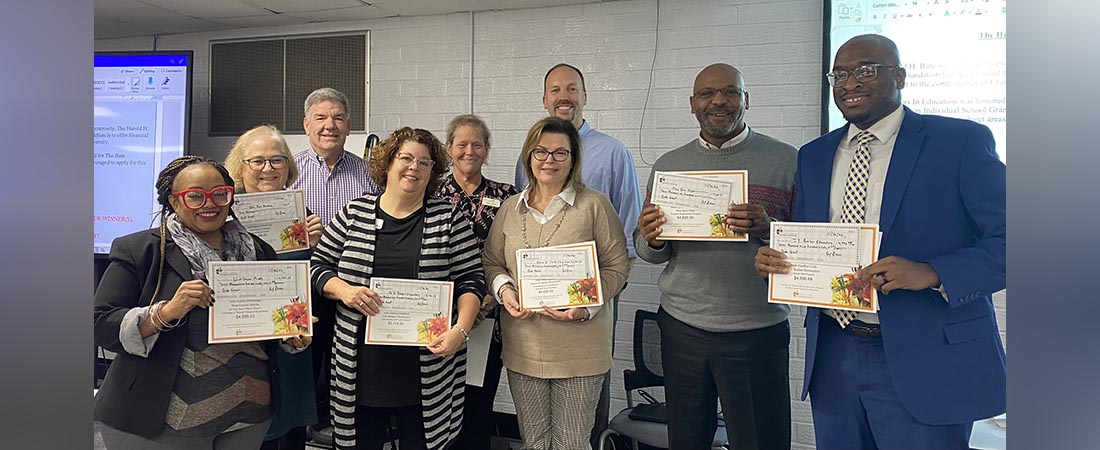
left=657, top=308, right=791, bottom=450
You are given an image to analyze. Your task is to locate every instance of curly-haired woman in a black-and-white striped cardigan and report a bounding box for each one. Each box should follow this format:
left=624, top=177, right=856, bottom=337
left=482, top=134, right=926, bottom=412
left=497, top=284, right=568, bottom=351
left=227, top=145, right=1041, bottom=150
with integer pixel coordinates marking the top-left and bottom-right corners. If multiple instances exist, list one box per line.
left=311, top=128, right=485, bottom=450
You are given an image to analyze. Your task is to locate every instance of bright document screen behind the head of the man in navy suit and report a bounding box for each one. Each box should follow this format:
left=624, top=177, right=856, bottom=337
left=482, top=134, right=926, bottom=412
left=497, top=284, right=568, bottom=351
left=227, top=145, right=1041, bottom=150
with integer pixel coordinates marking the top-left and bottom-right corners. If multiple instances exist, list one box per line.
left=826, top=0, right=1008, bottom=161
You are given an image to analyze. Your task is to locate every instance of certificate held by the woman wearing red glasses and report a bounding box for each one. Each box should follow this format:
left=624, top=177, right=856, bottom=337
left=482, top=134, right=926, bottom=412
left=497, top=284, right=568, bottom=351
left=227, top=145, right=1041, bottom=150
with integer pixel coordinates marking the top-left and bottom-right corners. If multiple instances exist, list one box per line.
left=207, top=261, right=314, bottom=343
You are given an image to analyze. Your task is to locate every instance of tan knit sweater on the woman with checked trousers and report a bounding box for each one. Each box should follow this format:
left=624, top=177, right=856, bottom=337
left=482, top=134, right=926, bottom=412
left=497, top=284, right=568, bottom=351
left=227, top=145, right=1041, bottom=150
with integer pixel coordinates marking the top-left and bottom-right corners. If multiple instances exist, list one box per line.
left=482, top=189, right=630, bottom=378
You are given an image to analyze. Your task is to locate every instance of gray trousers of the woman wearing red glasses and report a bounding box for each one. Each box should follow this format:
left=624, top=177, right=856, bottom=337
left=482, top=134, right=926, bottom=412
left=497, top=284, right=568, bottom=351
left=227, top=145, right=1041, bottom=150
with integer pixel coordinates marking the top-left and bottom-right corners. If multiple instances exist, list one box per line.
left=97, top=419, right=272, bottom=450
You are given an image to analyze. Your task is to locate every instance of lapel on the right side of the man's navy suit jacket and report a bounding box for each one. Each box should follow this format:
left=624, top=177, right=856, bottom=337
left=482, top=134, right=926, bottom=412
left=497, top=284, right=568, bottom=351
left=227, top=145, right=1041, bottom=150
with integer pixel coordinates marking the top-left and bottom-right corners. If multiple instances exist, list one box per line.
left=879, top=108, right=924, bottom=238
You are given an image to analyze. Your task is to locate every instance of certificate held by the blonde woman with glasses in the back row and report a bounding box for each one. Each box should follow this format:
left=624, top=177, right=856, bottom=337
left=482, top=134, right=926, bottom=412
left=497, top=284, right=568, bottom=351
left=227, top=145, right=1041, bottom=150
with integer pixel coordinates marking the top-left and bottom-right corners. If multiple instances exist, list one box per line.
left=233, top=189, right=309, bottom=253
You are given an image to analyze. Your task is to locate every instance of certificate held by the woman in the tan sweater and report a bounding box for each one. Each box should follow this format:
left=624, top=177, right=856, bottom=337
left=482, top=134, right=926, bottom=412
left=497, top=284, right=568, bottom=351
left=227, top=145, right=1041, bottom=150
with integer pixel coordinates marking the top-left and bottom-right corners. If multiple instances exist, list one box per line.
left=516, top=241, right=604, bottom=309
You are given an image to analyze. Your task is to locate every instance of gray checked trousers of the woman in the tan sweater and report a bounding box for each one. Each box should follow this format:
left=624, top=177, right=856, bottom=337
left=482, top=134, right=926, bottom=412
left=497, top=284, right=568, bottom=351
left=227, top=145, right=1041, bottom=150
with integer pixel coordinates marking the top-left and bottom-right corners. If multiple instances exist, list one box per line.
left=508, top=371, right=605, bottom=450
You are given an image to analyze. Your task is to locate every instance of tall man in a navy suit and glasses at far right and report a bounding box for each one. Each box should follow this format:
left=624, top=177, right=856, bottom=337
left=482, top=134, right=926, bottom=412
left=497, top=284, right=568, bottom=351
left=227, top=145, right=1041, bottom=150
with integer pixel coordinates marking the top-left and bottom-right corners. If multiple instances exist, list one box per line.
left=756, top=34, right=1005, bottom=450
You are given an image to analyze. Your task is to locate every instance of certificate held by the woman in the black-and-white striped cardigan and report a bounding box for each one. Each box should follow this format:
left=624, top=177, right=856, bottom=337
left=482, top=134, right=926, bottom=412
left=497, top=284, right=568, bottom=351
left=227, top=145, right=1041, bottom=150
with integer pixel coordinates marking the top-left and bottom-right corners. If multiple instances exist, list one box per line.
left=365, top=277, right=454, bottom=347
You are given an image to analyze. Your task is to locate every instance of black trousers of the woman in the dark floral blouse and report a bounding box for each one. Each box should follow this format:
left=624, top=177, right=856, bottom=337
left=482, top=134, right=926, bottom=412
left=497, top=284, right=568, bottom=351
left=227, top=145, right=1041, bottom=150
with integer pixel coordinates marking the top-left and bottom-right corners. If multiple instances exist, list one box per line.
left=451, top=332, right=504, bottom=444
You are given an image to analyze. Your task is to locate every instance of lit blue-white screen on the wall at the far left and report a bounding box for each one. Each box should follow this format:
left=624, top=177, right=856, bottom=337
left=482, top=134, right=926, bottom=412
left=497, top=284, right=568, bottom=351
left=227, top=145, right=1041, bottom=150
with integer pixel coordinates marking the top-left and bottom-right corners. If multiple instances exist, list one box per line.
left=92, top=51, right=194, bottom=255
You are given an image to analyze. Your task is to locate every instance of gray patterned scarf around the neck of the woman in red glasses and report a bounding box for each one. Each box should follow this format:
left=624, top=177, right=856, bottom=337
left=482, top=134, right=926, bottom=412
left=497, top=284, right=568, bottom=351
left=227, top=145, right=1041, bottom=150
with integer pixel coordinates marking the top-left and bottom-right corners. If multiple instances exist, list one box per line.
left=165, top=213, right=256, bottom=281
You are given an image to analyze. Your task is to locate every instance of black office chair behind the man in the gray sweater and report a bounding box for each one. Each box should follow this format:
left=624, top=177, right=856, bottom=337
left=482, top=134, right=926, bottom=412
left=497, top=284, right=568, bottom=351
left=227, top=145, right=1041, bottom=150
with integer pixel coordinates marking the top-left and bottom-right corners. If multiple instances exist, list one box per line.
left=600, top=309, right=726, bottom=450
